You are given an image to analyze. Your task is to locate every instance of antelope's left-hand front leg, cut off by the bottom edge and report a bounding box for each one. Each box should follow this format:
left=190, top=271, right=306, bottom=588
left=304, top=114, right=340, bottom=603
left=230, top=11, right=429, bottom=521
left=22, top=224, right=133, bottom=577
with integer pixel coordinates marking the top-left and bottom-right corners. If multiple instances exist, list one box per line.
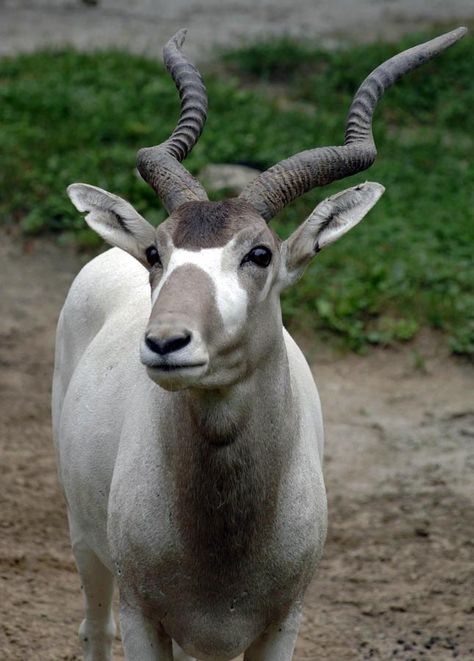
left=120, top=603, right=173, bottom=661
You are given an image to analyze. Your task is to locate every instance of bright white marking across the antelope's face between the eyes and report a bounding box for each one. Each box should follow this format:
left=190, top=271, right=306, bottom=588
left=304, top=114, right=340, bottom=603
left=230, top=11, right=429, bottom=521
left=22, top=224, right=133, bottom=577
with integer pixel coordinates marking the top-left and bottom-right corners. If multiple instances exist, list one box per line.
left=151, top=240, right=248, bottom=334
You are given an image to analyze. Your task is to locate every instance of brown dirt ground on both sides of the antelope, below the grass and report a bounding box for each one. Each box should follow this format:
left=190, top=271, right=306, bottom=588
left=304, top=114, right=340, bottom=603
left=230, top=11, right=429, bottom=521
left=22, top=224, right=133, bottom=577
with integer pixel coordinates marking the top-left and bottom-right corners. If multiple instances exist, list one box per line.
left=0, top=229, right=474, bottom=661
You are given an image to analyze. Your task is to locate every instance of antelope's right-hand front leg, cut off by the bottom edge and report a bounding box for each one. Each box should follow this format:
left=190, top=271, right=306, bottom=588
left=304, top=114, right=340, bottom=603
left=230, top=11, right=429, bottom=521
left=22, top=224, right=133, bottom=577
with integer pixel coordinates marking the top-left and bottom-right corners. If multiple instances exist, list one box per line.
left=244, top=603, right=302, bottom=661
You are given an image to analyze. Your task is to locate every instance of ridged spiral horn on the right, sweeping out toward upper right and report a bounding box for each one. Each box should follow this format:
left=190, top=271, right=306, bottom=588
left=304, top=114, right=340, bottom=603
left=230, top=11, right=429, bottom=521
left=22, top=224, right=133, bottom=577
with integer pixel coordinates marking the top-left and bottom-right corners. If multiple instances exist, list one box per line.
left=239, top=27, right=467, bottom=221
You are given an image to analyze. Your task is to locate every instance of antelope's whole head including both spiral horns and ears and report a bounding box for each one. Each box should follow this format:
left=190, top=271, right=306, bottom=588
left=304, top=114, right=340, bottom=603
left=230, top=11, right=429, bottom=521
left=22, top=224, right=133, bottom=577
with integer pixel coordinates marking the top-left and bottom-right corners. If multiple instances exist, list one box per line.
left=68, top=28, right=466, bottom=389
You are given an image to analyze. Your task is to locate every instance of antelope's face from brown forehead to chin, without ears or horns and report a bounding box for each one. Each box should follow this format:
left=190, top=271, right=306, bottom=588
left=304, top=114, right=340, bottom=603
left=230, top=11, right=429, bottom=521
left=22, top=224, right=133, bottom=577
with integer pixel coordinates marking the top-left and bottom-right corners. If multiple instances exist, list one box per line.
left=140, top=200, right=280, bottom=388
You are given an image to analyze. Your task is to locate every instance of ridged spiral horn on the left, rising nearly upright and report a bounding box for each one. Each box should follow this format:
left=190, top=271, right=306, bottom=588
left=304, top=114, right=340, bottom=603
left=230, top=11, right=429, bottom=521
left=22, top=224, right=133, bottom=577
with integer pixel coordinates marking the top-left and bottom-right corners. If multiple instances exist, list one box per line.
left=137, top=30, right=208, bottom=213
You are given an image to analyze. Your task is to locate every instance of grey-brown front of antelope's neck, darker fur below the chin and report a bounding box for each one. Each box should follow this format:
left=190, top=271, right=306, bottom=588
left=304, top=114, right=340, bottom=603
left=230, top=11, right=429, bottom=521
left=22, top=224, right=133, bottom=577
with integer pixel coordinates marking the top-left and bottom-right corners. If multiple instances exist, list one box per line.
left=161, top=340, right=298, bottom=568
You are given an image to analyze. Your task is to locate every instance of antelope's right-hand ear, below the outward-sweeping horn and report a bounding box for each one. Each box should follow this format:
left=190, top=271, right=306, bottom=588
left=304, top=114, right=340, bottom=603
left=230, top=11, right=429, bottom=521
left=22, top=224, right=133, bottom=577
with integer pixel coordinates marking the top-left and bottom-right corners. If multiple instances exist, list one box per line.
left=281, top=181, right=385, bottom=287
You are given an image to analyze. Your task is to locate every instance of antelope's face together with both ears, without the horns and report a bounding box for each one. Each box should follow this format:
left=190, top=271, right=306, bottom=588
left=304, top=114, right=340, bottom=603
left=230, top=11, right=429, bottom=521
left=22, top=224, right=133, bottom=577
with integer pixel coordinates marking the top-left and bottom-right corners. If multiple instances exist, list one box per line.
left=68, top=184, right=383, bottom=390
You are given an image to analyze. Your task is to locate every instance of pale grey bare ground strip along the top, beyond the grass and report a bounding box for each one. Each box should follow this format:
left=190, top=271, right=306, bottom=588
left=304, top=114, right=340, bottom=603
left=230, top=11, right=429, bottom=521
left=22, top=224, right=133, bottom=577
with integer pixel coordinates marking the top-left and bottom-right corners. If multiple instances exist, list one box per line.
left=0, top=0, right=474, bottom=59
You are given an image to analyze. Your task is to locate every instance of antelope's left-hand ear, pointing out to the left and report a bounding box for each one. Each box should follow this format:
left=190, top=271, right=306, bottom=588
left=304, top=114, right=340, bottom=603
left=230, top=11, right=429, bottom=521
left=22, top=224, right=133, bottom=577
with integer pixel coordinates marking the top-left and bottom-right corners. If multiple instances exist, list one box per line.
left=67, top=184, right=156, bottom=267
